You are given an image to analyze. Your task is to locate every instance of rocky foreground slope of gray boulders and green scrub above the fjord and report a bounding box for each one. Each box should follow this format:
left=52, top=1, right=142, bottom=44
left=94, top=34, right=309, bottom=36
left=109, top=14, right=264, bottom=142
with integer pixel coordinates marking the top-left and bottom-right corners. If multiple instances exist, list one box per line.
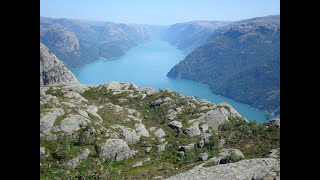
left=40, top=82, right=279, bottom=179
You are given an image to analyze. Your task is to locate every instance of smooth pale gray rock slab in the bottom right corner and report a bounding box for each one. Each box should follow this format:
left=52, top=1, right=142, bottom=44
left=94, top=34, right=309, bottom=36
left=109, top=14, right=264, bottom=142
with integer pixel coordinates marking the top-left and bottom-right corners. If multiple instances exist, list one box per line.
left=168, top=158, right=280, bottom=180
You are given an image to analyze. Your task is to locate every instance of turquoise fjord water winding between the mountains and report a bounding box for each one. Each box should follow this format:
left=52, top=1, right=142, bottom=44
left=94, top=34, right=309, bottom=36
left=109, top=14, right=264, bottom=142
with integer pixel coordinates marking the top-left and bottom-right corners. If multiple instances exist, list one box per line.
left=71, top=41, right=265, bottom=122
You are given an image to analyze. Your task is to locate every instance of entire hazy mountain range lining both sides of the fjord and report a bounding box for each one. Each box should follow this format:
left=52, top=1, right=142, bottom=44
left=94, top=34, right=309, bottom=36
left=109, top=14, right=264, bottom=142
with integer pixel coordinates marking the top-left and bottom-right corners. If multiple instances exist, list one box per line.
left=40, top=15, right=280, bottom=115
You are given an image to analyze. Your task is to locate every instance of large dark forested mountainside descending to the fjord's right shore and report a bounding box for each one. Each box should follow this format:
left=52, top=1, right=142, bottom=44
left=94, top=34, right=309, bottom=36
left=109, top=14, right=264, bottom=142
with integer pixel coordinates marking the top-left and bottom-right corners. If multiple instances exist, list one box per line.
left=168, top=15, right=280, bottom=115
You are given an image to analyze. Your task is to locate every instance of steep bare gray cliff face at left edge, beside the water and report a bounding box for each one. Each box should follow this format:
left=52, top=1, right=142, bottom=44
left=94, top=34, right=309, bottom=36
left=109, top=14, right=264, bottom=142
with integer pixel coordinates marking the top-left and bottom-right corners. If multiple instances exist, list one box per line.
left=40, top=43, right=78, bottom=86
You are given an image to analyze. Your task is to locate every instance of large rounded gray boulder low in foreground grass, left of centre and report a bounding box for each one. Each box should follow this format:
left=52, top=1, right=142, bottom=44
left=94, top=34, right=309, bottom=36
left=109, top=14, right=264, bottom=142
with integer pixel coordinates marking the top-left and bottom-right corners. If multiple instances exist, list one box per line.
left=96, top=139, right=131, bottom=161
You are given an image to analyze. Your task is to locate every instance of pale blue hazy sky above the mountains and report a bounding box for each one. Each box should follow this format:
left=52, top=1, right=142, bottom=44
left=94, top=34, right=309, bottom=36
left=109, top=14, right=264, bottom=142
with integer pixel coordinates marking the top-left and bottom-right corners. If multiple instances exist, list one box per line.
left=40, top=0, right=280, bottom=25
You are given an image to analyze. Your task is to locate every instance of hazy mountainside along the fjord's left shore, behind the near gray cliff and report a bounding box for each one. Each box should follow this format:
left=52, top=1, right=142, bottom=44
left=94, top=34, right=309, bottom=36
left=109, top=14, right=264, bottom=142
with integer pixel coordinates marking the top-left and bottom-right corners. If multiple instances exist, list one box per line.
left=40, top=17, right=152, bottom=68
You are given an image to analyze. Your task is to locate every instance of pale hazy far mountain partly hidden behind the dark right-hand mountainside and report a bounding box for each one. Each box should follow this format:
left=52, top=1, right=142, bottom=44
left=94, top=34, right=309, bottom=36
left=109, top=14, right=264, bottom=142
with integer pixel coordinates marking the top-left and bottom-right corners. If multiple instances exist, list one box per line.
left=163, top=21, right=230, bottom=51
